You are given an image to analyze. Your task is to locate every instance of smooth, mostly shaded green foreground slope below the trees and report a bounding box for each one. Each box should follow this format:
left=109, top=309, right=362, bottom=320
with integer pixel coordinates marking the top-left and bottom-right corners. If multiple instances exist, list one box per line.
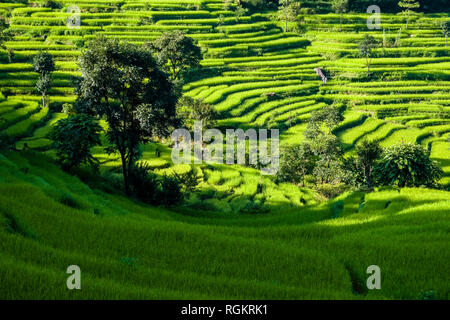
left=0, top=152, right=450, bottom=299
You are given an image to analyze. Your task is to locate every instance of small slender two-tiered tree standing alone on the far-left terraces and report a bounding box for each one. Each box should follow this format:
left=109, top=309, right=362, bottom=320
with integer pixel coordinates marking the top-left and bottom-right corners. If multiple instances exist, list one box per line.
left=33, top=52, right=55, bottom=107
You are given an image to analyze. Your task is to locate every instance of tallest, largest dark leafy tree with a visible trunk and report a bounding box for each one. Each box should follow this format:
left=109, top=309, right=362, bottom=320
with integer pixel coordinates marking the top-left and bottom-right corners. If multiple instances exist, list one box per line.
left=77, top=36, right=178, bottom=194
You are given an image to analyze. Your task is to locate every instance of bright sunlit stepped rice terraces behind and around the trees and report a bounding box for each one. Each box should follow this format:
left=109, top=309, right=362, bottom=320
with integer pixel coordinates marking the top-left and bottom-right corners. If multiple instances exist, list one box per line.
left=0, top=0, right=450, bottom=211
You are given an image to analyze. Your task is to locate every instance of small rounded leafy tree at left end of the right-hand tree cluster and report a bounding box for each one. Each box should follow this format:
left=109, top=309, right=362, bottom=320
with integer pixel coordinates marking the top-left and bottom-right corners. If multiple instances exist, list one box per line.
left=278, top=143, right=317, bottom=186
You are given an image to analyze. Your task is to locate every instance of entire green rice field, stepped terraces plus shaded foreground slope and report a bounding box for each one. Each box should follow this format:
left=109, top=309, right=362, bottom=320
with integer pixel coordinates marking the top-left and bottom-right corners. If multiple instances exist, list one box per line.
left=0, top=0, right=450, bottom=299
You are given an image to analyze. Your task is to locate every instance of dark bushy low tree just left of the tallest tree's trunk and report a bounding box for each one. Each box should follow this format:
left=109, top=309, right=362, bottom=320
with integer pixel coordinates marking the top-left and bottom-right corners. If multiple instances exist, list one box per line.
left=50, top=114, right=102, bottom=170
